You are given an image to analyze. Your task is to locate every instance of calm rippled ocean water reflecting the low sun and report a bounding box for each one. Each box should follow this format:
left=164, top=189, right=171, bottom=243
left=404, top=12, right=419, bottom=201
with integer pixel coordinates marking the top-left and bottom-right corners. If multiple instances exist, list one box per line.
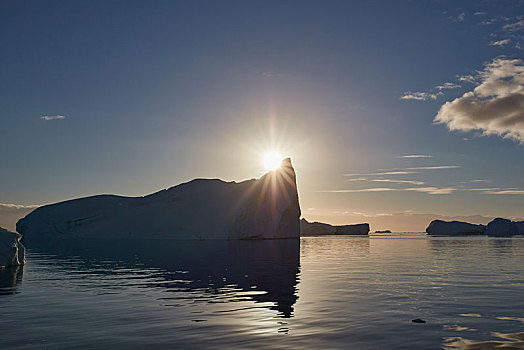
left=0, top=235, right=524, bottom=349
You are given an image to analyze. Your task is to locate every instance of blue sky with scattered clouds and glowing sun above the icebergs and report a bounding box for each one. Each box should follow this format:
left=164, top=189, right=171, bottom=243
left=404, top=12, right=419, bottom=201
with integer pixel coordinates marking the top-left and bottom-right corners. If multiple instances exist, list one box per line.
left=0, top=0, right=524, bottom=231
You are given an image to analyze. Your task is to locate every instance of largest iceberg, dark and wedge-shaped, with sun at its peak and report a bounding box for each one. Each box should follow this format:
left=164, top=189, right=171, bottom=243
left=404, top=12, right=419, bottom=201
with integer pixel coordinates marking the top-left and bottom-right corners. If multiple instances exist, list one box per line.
left=16, top=158, right=301, bottom=242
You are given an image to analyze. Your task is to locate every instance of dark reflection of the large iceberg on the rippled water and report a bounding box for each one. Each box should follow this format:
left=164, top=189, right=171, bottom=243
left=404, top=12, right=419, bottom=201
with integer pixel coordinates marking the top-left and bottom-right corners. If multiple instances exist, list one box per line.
left=24, top=240, right=300, bottom=318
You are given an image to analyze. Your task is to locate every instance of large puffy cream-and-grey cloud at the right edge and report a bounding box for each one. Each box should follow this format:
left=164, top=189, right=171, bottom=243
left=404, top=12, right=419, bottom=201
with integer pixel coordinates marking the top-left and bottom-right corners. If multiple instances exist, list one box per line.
left=435, top=58, right=524, bottom=143
